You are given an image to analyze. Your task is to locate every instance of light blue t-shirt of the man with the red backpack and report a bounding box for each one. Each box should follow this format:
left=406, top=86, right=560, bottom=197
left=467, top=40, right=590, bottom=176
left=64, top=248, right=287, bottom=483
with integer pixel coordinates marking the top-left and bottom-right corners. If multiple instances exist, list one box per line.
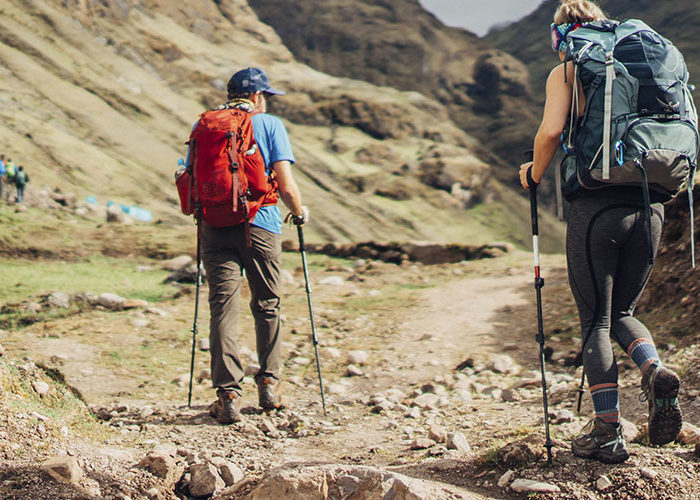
left=186, top=113, right=294, bottom=234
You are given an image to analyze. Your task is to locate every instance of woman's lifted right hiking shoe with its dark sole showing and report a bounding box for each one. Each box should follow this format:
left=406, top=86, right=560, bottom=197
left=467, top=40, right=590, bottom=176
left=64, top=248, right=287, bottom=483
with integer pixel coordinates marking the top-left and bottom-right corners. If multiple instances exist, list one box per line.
left=642, top=365, right=683, bottom=445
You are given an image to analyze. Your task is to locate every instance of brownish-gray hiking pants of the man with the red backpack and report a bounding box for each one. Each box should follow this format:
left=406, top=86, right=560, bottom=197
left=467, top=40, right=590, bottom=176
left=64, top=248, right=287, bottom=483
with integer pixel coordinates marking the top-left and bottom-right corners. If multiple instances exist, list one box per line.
left=202, top=224, right=282, bottom=394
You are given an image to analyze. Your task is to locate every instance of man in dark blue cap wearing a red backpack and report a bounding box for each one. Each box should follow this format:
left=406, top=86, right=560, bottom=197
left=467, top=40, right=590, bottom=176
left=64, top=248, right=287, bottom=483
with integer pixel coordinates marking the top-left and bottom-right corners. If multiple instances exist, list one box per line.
left=183, top=68, right=308, bottom=424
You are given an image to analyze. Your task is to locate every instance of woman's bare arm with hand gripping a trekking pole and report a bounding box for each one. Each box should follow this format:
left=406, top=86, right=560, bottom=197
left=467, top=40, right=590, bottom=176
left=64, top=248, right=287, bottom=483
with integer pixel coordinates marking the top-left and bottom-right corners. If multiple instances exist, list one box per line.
left=520, top=64, right=573, bottom=189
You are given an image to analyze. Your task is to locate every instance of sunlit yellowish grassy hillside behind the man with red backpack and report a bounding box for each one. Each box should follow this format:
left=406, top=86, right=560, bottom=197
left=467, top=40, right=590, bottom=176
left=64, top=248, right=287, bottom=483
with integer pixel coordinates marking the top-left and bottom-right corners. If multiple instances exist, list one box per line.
left=0, top=0, right=561, bottom=251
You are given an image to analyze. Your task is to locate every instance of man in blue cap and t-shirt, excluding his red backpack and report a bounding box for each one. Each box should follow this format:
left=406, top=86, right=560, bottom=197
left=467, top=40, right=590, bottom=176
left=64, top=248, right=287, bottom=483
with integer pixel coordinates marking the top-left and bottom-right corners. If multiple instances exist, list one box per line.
left=187, top=68, right=308, bottom=424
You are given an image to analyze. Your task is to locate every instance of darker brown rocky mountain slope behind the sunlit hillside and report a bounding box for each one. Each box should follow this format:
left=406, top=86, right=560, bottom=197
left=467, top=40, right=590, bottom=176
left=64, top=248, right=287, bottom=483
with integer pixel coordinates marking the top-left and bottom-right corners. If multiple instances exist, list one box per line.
left=250, top=0, right=538, bottom=177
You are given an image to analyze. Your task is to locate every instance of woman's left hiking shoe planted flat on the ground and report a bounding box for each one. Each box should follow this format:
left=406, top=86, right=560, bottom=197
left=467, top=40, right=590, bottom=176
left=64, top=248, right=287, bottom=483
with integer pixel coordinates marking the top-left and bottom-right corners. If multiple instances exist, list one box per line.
left=571, top=418, right=629, bottom=464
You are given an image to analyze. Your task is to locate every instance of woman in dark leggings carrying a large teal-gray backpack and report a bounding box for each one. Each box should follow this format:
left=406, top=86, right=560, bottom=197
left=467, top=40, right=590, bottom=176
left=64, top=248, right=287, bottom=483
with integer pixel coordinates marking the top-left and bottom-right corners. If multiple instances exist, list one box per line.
left=520, top=0, right=698, bottom=463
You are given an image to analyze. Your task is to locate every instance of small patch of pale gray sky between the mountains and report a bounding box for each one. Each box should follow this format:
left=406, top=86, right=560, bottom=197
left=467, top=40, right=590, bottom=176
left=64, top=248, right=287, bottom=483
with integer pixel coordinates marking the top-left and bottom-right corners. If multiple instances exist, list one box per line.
left=420, top=0, right=542, bottom=36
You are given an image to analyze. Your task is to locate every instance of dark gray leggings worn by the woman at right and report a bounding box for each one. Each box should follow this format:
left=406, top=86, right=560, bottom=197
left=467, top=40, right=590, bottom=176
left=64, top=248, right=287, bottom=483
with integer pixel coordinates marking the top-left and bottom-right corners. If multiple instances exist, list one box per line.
left=566, top=193, right=664, bottom=386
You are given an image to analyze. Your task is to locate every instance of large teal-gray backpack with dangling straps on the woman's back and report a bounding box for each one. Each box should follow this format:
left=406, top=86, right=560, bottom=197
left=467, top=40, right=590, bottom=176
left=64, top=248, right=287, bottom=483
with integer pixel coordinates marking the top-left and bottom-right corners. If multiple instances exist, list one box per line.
left=557, top=19, right=700, bottom=267
